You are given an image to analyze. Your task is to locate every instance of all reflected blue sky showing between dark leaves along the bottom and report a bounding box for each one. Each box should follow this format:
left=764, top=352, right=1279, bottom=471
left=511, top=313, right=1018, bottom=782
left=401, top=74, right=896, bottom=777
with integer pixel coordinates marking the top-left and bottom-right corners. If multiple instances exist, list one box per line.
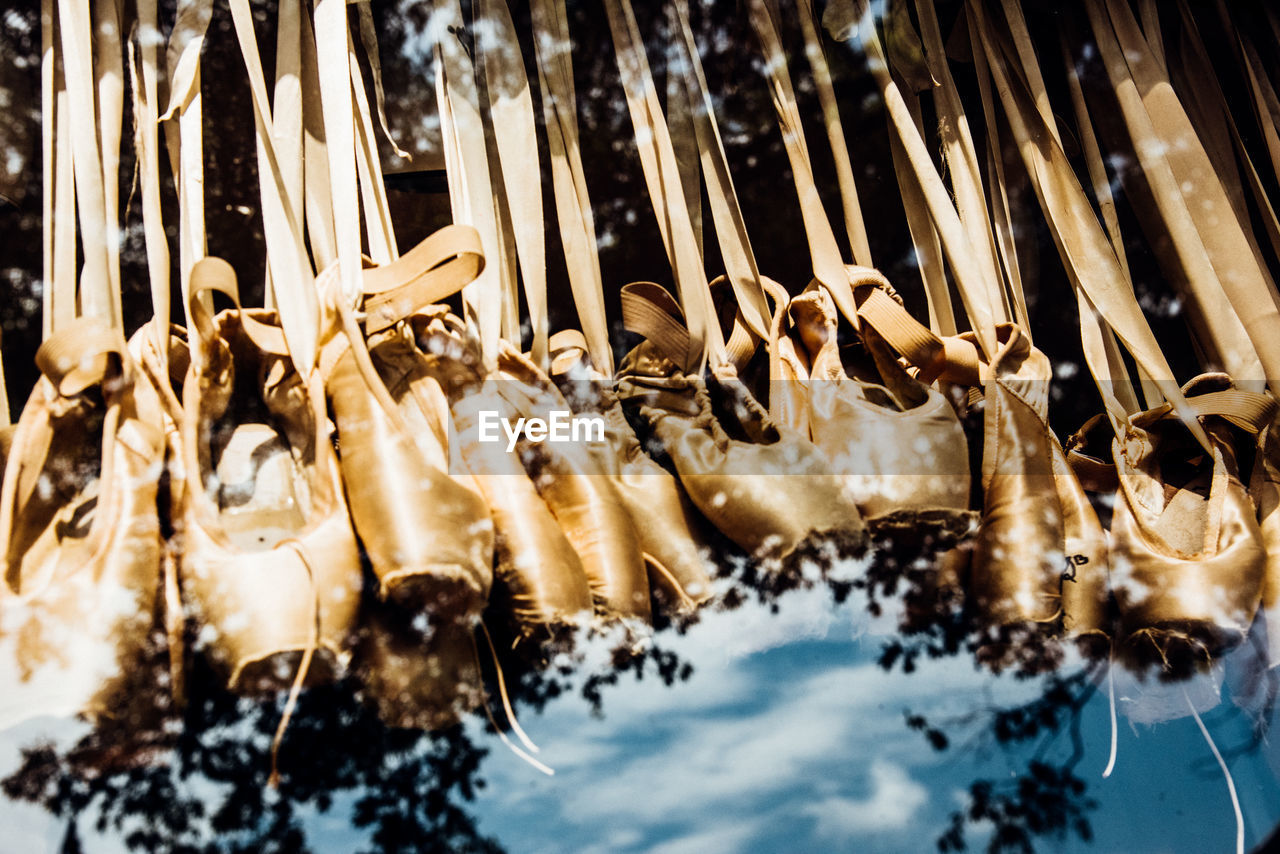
left=10, top=578, right=1280, bottom=854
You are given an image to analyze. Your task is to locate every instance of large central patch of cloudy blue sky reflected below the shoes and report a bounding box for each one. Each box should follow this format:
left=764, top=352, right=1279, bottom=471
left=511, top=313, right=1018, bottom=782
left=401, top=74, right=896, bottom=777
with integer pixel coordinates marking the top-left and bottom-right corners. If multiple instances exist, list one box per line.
left=465, top=592, right=1036, bottom=851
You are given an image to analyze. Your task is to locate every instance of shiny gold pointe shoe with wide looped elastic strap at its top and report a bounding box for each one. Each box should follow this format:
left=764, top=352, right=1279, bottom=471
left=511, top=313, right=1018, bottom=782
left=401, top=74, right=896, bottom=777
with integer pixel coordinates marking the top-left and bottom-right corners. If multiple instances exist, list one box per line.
left=317, top=225, right=494, bottom=620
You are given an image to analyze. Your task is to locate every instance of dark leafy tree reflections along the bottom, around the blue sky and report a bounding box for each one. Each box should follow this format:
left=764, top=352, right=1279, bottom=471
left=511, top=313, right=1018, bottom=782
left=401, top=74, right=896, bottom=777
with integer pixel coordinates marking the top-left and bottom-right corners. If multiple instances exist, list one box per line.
left=3, top=522, right=1111, bottom=854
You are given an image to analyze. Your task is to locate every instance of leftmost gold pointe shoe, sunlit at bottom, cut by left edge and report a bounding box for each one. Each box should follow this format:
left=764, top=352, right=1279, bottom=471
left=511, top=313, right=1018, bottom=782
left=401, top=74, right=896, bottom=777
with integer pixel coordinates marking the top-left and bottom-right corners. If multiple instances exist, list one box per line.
left=0, top=320, right=164, bottom=727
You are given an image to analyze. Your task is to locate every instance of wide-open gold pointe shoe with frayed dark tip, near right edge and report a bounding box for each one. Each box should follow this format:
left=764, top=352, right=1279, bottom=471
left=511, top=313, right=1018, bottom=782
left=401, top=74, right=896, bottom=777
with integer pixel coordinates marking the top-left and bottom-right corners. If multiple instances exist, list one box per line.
left=1068, top=374, right=1280, bottom=670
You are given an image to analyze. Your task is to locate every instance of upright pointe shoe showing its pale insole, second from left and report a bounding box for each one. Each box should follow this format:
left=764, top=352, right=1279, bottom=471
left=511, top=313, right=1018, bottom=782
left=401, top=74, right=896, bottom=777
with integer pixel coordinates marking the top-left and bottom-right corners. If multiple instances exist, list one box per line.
left=179, top=310, right=362, bottom=693
